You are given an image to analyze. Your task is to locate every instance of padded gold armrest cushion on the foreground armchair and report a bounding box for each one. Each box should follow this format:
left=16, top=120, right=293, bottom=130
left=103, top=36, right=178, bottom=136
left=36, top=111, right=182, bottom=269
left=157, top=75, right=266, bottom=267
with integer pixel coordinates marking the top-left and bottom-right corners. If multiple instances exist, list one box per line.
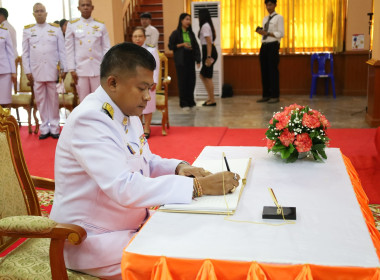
left=0, top=216, right=57, bottom=233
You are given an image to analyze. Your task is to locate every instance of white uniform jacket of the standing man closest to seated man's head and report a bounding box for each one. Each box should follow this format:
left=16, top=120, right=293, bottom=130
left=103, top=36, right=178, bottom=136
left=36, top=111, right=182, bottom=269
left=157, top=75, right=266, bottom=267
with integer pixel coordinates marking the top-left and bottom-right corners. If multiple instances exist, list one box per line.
left=65, top=17, right=110, bottom=77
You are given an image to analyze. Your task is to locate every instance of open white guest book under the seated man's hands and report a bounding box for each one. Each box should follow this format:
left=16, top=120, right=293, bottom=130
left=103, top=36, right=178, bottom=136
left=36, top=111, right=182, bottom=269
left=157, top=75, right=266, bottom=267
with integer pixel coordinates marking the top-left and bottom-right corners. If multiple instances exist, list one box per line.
left=158, top=158, right=252, bottom=214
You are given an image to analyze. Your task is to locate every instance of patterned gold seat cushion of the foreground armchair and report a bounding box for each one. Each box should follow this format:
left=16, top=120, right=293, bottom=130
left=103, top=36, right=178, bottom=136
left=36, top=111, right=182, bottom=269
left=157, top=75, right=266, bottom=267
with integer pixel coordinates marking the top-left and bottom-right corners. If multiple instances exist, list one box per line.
left=0, top=238, right=99, bottom=280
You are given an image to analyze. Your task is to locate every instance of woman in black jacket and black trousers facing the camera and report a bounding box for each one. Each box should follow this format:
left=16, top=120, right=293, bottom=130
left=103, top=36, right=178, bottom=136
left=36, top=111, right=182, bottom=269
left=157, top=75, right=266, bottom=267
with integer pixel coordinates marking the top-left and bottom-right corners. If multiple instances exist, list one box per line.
left=169, top=13, right=201, bottom=111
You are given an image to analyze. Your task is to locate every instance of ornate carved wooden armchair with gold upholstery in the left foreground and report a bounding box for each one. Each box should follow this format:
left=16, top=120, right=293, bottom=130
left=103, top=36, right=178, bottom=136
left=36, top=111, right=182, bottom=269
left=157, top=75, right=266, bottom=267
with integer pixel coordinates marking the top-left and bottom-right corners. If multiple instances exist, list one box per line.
left=0, top=106, right=98, bottom=280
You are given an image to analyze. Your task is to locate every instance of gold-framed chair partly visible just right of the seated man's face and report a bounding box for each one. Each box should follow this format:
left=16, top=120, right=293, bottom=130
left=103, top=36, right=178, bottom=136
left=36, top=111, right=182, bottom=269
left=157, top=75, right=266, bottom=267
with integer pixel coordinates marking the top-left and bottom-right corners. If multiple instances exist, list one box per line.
left=156, top=52, right=171, bottom=135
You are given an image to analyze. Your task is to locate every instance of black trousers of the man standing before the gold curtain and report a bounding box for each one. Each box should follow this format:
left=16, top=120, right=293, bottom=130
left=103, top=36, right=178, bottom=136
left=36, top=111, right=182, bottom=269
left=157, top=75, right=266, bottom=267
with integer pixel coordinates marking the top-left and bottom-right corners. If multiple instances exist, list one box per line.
left=260, top=42, right=280, bottom=98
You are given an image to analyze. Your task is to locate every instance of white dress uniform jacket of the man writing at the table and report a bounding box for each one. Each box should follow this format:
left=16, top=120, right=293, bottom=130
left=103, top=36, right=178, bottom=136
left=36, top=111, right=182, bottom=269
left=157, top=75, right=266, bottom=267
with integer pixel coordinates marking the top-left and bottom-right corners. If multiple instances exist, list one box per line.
left=51, top=86, right=193, bottom=270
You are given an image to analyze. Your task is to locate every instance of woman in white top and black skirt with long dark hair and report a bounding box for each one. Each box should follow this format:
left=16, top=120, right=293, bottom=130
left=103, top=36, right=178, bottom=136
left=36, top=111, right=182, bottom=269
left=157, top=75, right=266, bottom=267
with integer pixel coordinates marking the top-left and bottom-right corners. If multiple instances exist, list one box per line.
left=198, top=9, right=218, bottom=106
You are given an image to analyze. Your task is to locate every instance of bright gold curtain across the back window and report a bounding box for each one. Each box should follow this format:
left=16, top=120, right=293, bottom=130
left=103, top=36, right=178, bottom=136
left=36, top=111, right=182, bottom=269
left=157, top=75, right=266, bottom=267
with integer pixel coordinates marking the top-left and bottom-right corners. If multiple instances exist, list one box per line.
left=187, top=0, right=346, bottom=54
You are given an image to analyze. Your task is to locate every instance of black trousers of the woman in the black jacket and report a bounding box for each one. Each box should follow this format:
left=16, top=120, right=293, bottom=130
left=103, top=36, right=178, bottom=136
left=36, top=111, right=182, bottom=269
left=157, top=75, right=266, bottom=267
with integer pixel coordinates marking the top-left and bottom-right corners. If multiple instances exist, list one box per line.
left=176, top=53, right=195, bottom=108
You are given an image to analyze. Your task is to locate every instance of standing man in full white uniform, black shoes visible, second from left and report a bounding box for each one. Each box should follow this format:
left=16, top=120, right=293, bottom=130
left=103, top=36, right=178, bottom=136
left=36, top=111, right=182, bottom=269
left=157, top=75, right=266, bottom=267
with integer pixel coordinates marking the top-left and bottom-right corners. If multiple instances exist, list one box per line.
left=22, top=3, right=67, bottom=140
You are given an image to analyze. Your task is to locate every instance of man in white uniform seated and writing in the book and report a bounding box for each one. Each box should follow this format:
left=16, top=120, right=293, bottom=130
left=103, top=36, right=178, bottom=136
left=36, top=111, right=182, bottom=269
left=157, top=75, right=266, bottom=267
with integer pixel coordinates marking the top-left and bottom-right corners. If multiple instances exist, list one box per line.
left=50, top=43, right=239, bottom=279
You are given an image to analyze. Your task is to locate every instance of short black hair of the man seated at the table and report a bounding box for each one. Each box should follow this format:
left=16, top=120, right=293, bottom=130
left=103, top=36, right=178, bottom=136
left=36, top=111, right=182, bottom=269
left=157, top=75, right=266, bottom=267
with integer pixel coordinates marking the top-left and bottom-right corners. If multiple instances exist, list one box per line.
left=100, top=42, right=156, bottom=79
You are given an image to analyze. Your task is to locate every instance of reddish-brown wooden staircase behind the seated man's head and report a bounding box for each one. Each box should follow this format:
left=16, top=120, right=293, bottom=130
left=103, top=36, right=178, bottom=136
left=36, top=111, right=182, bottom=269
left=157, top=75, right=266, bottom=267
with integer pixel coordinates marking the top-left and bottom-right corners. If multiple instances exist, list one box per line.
left=124, top=0, right=164, bottom=52
